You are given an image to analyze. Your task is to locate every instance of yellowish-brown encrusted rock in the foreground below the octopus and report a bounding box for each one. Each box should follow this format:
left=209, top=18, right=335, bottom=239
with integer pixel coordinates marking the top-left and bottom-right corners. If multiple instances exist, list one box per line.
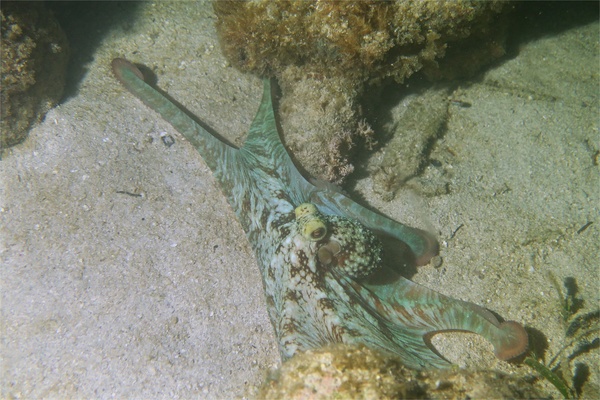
left=258, top=344, right=549, bottom=400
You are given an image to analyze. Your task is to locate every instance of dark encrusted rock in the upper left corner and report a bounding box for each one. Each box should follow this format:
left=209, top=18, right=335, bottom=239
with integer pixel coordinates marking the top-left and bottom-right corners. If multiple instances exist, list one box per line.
left=0, top=1, right=68, bottom=148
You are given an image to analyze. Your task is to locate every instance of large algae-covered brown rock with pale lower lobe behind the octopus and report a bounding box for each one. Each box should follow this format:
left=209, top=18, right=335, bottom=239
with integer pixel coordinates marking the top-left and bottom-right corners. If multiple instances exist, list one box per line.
left=215, top=0, right=511, bottom=183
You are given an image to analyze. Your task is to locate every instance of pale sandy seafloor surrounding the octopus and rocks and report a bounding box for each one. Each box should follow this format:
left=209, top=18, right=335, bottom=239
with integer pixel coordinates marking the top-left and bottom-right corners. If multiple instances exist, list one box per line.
left=0, top=2, right=600, bottom=398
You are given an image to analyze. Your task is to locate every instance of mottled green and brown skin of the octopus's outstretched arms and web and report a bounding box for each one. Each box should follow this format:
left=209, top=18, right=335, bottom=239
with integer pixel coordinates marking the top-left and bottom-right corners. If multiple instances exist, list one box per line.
left=112, top=59, right=527, bottom=369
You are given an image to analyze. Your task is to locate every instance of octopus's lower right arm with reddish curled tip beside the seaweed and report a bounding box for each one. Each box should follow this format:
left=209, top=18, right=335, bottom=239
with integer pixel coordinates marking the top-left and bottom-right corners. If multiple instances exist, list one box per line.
left=339, top=276, right=528, bottom=367
